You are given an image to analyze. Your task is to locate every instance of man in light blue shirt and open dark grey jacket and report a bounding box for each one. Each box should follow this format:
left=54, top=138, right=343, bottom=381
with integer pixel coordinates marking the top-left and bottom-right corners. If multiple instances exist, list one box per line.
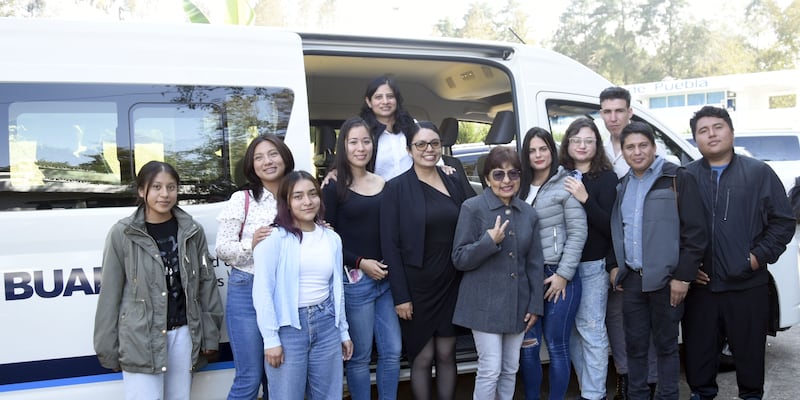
left=611, top=122, right=708, bottom=400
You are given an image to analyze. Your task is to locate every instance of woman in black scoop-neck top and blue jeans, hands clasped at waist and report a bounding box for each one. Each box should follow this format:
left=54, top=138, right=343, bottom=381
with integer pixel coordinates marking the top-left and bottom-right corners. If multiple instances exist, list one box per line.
left=322, top=117, right=402, bottom=400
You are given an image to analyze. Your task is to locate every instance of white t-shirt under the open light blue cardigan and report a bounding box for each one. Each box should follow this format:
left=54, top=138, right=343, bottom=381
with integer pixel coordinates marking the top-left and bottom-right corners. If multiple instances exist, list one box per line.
left=297, top=225, right=334, bottom=307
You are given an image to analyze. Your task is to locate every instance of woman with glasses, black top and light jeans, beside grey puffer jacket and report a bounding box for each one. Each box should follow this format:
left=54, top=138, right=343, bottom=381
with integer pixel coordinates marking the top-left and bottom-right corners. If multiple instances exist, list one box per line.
left=559, top=118, right=617, bottom=400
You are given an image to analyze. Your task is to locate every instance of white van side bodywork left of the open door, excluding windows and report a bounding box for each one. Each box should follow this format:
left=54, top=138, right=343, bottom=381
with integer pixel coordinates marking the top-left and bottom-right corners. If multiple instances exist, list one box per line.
left=0, top=19, right=313, bottom=400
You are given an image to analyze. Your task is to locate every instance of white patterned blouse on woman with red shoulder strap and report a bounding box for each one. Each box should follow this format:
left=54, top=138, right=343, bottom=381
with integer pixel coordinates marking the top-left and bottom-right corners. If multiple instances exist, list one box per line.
left=216, top=189, right=278, bottom=274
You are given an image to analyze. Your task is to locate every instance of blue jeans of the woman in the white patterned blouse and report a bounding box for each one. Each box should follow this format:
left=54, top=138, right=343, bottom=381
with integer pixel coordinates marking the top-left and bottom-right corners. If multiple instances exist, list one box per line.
left=225, top=268, right=267, bottom=400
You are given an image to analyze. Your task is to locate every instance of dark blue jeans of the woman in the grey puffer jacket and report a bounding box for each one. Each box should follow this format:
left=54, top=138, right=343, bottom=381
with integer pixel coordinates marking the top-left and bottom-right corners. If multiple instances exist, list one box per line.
left=519, top=265, right=581, bottom=400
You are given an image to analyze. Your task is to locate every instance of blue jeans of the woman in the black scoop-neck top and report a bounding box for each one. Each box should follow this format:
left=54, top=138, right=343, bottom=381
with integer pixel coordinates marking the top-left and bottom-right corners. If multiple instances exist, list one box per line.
left=344, top=275, right=402, bottom=400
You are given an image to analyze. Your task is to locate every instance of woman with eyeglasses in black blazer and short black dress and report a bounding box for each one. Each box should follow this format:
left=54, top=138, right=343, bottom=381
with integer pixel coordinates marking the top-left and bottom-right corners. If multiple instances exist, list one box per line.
left=381, top=121, right=467, bottom=400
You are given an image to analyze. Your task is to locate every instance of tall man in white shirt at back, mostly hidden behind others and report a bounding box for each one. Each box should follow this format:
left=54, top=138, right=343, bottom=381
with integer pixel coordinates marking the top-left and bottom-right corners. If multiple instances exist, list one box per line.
left=600, top=86, right=665, bottom=400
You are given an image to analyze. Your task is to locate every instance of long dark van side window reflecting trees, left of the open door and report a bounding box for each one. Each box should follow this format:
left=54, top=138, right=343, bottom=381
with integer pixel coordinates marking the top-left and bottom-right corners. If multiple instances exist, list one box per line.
left=0, top=83, right=294, bottom=211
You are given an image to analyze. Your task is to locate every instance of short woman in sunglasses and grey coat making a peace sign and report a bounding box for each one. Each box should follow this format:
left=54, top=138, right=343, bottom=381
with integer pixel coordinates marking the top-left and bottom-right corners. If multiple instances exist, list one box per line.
left=453, top=146, right=544, bottom=400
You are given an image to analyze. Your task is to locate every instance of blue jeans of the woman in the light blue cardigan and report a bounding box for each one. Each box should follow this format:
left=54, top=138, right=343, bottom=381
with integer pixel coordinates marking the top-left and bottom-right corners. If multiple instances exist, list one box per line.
left=261, top=297, right=344, bottom=400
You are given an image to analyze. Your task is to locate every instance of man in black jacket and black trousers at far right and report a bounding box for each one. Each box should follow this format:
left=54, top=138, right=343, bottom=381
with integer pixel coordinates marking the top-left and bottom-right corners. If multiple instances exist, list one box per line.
left=683, top=106, right=795, bottom=400
